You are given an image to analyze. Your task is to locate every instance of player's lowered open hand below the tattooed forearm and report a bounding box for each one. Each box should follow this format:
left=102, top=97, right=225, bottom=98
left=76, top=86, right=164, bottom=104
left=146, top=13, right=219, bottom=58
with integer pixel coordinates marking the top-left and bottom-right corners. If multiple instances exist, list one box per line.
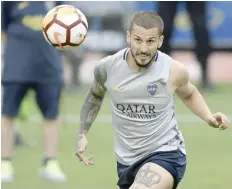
left=76, top=134, right=94, bottom=166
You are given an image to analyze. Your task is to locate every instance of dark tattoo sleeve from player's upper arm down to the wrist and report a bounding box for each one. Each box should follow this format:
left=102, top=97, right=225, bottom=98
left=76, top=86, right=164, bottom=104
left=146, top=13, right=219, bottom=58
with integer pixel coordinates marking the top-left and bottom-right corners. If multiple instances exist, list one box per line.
left=79, top=63, right=107, bottom=134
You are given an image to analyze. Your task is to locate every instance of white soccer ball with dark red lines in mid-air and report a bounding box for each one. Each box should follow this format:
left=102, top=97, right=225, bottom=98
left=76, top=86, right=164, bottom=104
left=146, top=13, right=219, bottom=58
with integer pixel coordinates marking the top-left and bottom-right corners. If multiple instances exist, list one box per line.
left=43, top=5, right=88, bottom=50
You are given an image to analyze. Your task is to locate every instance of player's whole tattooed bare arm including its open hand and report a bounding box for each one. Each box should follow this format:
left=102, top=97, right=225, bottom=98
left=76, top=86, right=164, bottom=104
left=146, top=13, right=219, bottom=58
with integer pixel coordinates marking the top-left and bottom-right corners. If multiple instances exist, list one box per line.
left=76, top=58, right=107, bottom=166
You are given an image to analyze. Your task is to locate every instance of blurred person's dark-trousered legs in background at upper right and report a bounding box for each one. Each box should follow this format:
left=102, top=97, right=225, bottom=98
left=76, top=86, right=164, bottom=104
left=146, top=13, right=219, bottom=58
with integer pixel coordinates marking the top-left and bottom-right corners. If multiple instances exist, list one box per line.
left=158, top=1, right=213, bottom=89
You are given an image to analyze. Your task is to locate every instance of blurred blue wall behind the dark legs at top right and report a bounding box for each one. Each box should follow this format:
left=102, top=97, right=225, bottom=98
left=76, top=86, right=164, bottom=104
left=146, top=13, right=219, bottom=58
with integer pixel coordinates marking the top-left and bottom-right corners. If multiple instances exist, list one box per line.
left=136, top=1, right=232, bottom=48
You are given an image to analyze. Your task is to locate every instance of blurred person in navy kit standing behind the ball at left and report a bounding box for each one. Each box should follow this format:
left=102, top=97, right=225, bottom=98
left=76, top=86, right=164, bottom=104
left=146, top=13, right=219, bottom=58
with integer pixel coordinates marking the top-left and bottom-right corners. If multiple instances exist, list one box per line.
left=1, top=1, right=66, bottom=182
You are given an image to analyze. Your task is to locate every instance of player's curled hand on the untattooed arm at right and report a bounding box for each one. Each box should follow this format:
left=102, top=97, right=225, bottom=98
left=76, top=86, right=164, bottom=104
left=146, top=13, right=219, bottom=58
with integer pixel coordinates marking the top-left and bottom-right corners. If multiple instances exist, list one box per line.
left=206, top=112, right=229, bottom=130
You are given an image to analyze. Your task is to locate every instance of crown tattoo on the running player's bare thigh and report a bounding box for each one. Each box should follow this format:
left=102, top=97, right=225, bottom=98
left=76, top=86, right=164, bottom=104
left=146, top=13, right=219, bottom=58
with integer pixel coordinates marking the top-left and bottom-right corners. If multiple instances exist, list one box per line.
left=135, top=165, right=161, bottom=188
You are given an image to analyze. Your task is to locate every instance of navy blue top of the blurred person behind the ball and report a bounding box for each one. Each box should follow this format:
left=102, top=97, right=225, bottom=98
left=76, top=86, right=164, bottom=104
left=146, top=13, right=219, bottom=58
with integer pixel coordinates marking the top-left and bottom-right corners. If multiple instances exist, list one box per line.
left=1, top=1, right=63, bottom=83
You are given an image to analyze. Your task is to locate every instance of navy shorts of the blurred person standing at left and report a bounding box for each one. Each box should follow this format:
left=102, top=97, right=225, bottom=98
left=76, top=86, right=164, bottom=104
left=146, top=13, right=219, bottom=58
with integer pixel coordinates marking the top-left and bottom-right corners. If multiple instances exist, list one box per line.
left=2, top=83, right=62, bottom=119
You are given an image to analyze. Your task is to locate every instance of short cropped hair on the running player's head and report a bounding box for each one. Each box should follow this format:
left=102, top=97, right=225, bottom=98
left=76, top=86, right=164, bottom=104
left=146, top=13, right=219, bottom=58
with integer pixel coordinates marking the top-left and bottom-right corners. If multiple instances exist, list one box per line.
left=129, top=11, right=164, bottom=35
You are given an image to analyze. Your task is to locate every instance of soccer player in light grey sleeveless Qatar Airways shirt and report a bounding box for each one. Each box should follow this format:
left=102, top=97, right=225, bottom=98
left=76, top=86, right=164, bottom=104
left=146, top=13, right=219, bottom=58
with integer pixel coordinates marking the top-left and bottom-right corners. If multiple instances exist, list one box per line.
left=76, top=12, right=229, bottom=189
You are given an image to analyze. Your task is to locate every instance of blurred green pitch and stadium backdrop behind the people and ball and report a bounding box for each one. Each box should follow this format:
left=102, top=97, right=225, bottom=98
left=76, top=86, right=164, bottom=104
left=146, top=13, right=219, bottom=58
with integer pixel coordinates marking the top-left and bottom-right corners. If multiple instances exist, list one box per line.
left=1, top=1, right=232, bottom=189
